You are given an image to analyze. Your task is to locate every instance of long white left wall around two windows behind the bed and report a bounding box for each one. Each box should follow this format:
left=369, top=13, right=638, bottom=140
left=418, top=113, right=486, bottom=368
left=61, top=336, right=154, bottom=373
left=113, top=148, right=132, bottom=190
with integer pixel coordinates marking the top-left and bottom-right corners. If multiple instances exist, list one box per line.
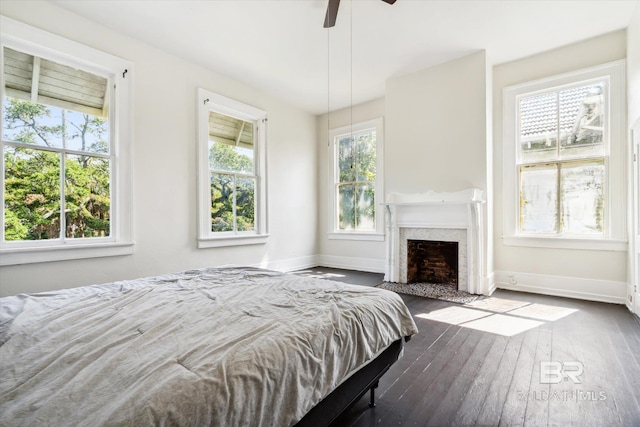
left=0, top=1, right=318, bottom=295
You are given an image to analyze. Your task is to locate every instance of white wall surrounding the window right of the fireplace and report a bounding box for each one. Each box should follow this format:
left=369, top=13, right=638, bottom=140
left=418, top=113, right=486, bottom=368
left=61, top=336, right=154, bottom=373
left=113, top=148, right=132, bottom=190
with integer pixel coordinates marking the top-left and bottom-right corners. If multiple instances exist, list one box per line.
left=493, top=30, right=627, bottom=303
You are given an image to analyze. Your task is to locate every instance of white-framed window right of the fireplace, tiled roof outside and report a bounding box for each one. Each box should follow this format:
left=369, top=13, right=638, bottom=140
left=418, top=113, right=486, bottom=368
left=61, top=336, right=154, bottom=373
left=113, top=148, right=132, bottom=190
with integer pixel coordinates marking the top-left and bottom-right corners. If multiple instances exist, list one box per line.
left=504, top=63, right=626, bottom=248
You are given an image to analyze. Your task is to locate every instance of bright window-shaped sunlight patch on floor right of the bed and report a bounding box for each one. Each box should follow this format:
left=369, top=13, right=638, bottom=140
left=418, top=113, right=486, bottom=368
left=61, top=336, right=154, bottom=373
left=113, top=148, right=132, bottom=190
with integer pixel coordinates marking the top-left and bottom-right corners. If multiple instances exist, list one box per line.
left=416, top=297, right=578, bottom=337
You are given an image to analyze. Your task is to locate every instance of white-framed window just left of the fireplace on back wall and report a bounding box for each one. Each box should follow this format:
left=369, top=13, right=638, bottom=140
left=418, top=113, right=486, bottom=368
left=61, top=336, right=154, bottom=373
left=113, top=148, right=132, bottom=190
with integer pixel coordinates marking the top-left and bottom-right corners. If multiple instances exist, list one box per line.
left=329, top=119, right=384, bottom=240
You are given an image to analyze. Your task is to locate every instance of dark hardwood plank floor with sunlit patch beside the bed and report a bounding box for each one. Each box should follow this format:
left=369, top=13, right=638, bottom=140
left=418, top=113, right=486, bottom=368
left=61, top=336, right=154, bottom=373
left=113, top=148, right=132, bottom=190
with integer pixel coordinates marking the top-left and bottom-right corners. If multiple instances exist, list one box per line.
left=296, top=269, right=640, bottom=426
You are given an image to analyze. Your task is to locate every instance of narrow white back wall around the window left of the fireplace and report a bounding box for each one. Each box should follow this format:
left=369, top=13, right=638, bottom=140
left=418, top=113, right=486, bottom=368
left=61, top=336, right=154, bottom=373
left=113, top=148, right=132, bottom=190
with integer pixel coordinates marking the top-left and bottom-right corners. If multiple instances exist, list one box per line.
left=317, top=98, right=386, bottom=273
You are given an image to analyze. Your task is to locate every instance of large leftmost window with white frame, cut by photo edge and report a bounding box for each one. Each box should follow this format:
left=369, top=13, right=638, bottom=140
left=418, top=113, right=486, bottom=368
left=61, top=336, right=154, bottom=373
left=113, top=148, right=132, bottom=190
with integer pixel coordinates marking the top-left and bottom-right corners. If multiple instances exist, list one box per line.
left=0, top=17, right=132, bottom=265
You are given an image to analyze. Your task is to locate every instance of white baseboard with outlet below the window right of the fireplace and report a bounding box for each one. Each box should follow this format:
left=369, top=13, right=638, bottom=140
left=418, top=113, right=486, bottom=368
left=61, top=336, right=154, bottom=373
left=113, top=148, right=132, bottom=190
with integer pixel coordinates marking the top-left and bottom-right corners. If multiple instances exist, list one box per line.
left=495, top=270, right=627, bottom=304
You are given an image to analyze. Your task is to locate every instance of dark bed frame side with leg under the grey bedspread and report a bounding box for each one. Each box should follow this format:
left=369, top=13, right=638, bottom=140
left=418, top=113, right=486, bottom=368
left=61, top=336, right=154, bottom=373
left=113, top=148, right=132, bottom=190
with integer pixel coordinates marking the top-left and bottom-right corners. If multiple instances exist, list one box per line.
left=296, top=337, right=411, bottom=427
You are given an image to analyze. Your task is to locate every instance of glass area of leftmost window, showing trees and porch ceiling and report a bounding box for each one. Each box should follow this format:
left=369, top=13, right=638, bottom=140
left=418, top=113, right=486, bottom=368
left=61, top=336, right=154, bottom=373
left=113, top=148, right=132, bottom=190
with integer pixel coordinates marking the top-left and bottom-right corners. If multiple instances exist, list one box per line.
left=2, top=47, right=114, bottom=242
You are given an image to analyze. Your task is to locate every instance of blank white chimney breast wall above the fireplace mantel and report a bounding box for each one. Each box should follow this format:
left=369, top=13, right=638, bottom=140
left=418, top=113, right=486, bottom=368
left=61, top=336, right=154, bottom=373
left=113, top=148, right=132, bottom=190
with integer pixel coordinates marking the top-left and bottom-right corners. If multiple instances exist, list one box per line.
left=385, top=51, right=493, bottom=289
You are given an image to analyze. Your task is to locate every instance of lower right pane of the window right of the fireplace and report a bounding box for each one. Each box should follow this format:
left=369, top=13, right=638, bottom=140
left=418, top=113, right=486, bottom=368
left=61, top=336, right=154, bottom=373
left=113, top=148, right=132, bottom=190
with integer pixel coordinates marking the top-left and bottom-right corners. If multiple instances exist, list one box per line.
left=561, top=161, right=604, bottom=234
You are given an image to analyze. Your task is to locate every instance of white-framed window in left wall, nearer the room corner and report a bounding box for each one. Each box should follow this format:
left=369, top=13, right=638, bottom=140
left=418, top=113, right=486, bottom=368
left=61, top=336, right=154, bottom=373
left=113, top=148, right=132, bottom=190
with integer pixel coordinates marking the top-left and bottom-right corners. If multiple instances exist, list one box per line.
left=198, top=89, right=267, bottom=247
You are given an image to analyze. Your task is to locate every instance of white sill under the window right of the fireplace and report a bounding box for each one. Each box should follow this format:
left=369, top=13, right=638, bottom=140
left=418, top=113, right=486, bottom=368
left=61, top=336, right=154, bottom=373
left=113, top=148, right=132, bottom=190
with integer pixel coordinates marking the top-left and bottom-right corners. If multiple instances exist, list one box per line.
left=502, top=236, right=628, bottom=252
